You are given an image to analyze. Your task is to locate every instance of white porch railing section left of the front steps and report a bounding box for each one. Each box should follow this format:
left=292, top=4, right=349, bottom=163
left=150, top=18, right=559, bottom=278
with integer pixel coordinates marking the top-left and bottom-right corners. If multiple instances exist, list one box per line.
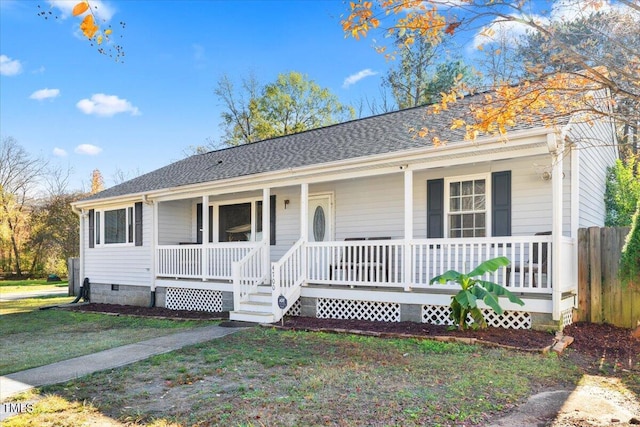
left=156, top=242, right=256, bottom=281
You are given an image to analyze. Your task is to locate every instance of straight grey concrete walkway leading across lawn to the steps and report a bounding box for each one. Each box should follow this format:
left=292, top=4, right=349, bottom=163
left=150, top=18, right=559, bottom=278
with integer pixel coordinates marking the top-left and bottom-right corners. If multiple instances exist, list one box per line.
left=0, top=325, right=241, bottom=402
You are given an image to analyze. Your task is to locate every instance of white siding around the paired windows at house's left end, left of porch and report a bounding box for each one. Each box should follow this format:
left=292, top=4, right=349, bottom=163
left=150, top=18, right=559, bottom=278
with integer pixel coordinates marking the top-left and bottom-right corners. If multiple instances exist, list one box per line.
left=83, top=204, right=153, bottom=286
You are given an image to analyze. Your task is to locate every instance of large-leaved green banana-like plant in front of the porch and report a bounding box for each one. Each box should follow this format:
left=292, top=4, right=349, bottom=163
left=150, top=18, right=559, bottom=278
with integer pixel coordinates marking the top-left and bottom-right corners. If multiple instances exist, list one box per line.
left=429, top=257, right=524, bottom=330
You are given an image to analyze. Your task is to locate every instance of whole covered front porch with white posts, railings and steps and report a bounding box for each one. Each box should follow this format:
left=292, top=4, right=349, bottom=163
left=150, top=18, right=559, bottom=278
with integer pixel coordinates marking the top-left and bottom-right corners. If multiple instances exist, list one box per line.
left=153, top=133, right=577, bottom=323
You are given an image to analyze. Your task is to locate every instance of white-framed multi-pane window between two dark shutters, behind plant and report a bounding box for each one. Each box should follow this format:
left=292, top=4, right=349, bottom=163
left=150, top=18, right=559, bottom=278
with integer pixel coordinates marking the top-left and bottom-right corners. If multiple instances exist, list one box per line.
left=446, top=178, right=488, bottom=237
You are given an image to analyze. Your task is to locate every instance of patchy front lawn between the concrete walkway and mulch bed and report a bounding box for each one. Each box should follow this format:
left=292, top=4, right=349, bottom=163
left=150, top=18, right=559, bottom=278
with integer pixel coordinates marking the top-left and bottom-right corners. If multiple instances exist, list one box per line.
left=6, top=328, right=580, bottom=426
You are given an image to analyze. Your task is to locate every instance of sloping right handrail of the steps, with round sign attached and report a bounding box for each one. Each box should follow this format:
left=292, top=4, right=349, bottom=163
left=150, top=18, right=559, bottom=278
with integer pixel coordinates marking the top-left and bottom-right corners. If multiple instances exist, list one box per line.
left=271, top=239, right=307, bottom=322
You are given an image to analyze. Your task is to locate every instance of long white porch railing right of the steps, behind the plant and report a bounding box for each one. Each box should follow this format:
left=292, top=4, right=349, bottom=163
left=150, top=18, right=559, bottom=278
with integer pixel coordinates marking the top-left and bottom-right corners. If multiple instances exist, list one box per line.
left=306, top=235, right=556, bottom=294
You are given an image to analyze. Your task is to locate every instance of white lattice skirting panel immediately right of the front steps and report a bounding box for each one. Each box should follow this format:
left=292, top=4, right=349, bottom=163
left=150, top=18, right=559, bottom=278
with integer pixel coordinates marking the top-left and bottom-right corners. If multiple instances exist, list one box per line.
left=316, top=298, right=400, bottom=322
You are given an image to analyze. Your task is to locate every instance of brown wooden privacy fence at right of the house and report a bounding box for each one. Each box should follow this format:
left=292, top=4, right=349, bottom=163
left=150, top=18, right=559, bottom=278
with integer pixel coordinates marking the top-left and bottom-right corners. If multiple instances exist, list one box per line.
left=576, top=227, right=640, bottom=328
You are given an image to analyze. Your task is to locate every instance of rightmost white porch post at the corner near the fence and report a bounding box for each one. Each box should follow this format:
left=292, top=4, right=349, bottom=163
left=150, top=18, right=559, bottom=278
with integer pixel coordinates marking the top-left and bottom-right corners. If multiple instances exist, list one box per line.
left=547, top=134, right=571, bottom=320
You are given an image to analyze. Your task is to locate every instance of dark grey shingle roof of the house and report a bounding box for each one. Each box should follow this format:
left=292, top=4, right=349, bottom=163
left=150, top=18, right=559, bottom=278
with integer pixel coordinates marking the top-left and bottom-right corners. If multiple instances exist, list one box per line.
left=83, top=96, right=535, bottom=201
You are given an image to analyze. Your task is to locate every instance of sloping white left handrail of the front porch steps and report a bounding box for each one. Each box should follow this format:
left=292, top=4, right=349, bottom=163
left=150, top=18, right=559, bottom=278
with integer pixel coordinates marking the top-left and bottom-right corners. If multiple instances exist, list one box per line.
left=231, top=242, right=268, bottom=311
